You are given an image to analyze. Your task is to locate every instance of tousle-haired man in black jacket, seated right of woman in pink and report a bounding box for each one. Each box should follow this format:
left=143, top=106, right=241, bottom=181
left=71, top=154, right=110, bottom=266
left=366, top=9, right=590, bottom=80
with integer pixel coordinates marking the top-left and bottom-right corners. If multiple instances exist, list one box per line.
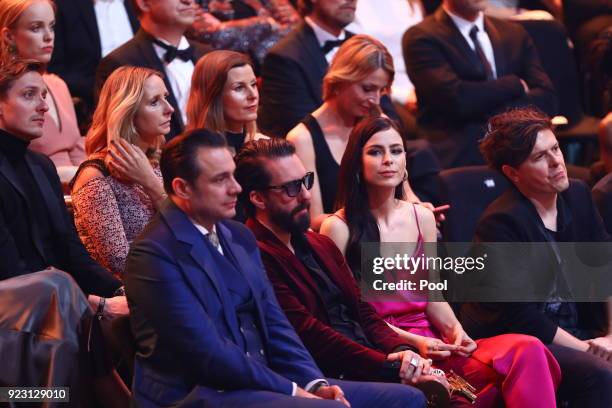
left=461, top=108, right=612, bottom=407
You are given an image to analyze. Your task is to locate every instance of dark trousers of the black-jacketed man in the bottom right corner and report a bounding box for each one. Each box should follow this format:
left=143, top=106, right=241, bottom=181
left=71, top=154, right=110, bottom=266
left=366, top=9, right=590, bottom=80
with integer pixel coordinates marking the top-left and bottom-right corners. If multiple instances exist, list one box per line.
left=547, top=344, right=612, bottom=408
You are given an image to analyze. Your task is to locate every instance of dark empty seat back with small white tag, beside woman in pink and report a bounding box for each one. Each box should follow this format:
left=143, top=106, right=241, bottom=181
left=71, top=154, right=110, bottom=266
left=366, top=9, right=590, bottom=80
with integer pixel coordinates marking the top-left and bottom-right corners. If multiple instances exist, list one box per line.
left=440, top=166, right=508, bottom=242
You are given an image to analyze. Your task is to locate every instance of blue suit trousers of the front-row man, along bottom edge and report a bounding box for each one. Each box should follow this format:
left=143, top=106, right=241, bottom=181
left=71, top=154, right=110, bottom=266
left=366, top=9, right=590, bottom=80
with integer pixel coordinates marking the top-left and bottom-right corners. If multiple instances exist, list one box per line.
left=181, top=379, right=425, bottom=408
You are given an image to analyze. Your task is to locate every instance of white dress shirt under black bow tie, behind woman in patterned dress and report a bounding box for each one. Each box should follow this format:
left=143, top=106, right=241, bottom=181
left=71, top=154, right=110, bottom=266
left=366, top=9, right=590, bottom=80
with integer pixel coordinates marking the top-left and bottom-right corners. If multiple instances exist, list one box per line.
left=153, top=36, right=194, bottom=123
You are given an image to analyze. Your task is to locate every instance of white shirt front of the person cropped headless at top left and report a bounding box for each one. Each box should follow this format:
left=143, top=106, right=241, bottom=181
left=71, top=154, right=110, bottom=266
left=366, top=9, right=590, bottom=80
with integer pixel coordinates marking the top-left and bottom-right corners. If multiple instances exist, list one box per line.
left=93, top=0, right=134, bottom=58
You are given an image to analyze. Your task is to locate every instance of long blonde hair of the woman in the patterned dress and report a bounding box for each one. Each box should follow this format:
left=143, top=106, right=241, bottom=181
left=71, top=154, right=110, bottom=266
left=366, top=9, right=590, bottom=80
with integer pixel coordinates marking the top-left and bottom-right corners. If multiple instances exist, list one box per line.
left=85, top=65, right=164, bottom=159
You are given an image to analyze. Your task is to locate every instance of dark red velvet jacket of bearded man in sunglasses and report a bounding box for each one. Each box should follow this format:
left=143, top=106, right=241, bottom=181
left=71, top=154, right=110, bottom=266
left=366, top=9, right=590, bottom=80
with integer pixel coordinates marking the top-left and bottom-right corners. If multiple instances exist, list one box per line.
left=247, top=218, right=406, bottom=381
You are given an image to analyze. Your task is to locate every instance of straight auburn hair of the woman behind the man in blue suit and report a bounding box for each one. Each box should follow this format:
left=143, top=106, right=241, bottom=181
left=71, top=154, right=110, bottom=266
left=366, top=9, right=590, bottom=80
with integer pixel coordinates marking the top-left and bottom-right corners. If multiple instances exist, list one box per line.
left=186, top=50, right=257, bottom=141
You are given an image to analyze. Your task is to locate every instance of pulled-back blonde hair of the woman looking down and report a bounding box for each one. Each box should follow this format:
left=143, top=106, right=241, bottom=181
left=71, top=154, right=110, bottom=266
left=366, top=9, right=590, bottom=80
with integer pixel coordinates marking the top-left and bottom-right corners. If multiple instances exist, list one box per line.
left=323, top=34, right=395, bottom=101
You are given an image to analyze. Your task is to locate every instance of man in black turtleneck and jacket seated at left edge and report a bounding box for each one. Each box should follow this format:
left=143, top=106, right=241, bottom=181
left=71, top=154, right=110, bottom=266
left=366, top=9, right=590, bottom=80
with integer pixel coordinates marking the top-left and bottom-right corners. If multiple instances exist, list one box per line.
left=0, top=60, right=128, bottom=407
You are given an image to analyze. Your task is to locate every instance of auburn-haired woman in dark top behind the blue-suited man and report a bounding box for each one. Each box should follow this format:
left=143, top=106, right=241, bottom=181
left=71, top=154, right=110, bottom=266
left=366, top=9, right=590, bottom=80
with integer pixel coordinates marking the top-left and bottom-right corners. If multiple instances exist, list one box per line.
left=187, top=50, right=263, bottom=155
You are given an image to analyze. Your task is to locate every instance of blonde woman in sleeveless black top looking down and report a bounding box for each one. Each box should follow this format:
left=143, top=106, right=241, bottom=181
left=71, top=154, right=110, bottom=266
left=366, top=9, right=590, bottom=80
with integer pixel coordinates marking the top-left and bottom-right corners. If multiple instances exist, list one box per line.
left=287, top=34, right=432, bottom=230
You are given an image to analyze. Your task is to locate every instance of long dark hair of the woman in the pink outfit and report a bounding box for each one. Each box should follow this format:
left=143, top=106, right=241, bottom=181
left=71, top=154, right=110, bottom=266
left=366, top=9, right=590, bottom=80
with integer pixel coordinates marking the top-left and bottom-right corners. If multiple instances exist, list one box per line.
left=335, top=116, right=406, bottom=271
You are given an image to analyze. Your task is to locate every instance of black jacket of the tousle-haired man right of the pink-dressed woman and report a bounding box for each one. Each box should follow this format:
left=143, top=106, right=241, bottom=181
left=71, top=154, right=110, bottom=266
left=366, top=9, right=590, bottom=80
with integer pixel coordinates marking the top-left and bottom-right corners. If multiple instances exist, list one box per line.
left=461, top=180, right=610, bottom=344
